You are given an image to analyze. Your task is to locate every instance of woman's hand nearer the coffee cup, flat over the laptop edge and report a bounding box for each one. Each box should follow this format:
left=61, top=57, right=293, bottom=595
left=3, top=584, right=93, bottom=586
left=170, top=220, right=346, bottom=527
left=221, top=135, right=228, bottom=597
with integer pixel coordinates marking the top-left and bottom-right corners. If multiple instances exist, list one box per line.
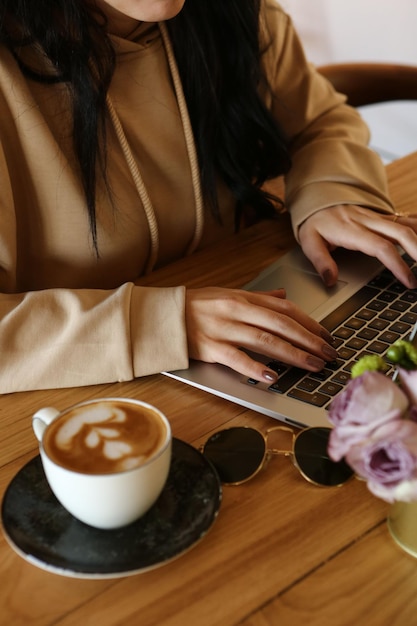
left=186, top=287, right=337, bottom=383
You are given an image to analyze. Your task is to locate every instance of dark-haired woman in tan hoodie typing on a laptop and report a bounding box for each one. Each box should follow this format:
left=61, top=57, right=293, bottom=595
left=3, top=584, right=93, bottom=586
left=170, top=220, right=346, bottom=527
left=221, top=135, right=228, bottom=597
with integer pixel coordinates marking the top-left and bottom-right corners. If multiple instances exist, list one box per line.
left=0, top=0, right=417, bottom=393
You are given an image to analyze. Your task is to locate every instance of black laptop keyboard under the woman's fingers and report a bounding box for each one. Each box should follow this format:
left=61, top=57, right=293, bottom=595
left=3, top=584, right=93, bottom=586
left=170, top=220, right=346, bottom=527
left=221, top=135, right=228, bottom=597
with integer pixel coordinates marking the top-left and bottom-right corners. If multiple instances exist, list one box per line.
left=247, top=255, right=417, bottom=409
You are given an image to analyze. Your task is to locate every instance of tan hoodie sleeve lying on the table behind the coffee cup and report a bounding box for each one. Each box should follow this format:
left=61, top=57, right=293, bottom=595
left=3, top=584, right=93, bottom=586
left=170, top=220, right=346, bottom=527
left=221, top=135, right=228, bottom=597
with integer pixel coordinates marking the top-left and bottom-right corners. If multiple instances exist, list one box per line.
left=0, top=283, right=188, bottom=393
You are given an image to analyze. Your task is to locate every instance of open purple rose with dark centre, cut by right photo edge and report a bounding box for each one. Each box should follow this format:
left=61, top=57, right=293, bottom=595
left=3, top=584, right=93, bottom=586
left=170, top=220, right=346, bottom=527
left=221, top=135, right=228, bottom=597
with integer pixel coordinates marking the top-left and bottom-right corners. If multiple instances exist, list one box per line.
left=346, top=419, right=417, bottom=502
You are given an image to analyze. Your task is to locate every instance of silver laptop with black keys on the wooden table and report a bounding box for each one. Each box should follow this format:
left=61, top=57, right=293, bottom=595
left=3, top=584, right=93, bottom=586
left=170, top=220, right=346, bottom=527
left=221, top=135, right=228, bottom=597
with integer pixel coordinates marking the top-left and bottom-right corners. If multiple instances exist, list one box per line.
left=164, top=248, right=417, bottom=428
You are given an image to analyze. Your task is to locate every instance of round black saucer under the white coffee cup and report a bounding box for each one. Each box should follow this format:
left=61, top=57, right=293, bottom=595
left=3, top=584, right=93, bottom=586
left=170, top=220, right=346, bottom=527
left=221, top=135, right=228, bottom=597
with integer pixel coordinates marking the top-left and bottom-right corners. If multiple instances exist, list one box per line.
left=2, top=439, right=221, bottom=578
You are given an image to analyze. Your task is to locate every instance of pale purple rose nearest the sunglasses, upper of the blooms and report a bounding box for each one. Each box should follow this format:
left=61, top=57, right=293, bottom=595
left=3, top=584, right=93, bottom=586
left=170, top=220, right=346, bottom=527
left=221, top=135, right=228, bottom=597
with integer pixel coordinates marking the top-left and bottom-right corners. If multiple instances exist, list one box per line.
left=328, top=371, right=408, bottom=461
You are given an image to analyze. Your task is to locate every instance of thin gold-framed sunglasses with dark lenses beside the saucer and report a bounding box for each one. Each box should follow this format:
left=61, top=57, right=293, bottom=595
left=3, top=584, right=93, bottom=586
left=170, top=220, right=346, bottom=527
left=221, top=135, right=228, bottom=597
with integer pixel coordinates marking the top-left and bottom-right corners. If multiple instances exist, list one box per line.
left=200, top=426, right=354, bottom=487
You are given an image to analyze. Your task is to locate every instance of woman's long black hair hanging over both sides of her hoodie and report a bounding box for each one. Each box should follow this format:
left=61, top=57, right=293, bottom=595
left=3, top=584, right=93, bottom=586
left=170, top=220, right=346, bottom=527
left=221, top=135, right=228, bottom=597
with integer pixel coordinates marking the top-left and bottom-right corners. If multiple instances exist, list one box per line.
left=0, top=0, right=290, bottom=244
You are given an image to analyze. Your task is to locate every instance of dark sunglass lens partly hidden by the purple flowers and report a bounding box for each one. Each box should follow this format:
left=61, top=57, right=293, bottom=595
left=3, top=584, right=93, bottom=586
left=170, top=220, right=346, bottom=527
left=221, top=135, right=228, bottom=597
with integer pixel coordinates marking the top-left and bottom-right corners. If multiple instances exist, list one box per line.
left=294, top=428, right=354, bottom=487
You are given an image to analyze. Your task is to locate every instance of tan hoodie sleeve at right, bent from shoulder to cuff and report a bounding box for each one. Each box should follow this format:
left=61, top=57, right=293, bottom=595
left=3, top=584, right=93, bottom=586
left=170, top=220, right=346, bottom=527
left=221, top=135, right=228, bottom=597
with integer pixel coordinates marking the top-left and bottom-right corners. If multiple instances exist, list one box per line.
left=261, top=0, right=393, bottom=236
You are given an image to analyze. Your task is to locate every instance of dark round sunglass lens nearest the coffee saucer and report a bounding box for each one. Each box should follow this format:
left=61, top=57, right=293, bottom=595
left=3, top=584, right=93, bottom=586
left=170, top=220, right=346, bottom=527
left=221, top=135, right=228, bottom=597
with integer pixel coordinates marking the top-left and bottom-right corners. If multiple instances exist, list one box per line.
left=203, top=426, right=265, bottom=484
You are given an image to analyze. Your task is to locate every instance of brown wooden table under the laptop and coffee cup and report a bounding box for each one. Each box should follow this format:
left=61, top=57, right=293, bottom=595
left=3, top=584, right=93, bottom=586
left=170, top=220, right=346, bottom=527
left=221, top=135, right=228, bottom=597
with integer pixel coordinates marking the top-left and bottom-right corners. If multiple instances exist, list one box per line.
left=0, top=153, right=417, bottom=626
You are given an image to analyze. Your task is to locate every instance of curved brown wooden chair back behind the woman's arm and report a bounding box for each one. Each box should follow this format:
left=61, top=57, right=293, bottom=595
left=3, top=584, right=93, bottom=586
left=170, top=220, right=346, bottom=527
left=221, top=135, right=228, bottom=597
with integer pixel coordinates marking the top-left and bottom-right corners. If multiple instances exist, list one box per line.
left=318, top=62, right=417, bottom=107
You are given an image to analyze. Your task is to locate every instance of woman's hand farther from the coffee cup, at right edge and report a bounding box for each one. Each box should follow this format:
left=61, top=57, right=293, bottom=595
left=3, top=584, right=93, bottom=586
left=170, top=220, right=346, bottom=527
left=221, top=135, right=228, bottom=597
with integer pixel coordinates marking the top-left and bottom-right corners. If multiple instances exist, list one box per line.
left=299, top=205, right=417, bottom=289
